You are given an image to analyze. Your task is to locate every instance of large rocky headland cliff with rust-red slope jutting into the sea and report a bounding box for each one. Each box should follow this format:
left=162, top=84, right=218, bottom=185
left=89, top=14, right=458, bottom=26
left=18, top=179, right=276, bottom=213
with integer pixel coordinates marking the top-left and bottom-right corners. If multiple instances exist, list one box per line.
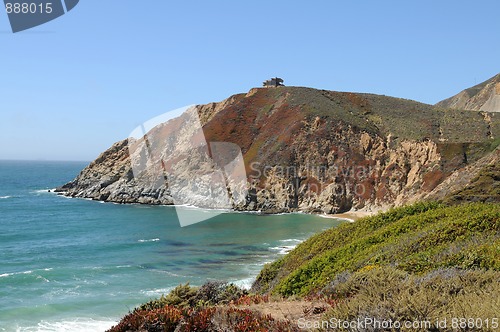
left=58, top=87, right=500, bottom=213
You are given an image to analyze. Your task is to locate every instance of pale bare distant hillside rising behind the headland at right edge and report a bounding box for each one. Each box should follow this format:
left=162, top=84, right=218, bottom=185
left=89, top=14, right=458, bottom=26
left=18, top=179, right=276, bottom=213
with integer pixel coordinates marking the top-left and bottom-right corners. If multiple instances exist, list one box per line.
left=436, top=74, right=500, bottom=112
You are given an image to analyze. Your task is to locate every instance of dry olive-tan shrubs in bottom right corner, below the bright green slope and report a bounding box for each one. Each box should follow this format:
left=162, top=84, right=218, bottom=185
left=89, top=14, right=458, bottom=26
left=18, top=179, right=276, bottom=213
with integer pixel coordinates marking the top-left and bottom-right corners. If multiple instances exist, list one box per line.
left=324, top=267, right=500, bottom=331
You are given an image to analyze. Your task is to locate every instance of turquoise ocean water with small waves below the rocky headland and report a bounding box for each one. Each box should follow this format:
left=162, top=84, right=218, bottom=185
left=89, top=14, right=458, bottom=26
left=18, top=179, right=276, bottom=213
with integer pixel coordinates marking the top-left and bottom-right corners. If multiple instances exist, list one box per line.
left=0, top=161, right=341, bottom=331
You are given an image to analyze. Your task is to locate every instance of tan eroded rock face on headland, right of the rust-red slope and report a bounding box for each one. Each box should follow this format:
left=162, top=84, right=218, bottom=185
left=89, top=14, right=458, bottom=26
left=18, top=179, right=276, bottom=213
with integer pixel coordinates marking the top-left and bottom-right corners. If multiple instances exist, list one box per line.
left=242, top=120, right=443, bottom=213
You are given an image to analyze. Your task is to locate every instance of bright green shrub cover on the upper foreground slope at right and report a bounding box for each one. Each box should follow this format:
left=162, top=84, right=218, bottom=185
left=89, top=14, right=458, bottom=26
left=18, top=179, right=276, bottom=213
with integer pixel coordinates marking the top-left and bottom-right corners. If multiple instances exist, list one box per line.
left=253, top=203, right=500, bottom=296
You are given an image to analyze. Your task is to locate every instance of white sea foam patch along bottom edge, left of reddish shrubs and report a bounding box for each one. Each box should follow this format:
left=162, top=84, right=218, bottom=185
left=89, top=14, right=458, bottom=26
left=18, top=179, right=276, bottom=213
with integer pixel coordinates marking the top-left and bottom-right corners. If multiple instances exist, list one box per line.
left=16, top=318, right=118, bottom=332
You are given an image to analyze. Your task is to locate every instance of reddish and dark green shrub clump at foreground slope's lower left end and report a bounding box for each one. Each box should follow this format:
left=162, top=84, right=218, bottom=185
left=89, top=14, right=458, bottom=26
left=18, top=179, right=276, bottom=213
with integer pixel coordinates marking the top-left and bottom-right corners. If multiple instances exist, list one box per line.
left=109, top=281, right=299, bottom=332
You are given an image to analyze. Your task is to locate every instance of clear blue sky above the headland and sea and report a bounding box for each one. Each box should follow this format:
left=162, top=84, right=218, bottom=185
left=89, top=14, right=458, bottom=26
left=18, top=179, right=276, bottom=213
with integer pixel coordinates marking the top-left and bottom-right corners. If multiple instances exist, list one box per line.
left=0, top=0, right=500, bottom=160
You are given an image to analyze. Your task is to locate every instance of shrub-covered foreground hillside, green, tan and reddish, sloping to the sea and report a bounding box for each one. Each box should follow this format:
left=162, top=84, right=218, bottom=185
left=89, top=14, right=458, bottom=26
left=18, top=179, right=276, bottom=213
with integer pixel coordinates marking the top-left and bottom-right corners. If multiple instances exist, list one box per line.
left=110, top=203, right=500, bottom=332
